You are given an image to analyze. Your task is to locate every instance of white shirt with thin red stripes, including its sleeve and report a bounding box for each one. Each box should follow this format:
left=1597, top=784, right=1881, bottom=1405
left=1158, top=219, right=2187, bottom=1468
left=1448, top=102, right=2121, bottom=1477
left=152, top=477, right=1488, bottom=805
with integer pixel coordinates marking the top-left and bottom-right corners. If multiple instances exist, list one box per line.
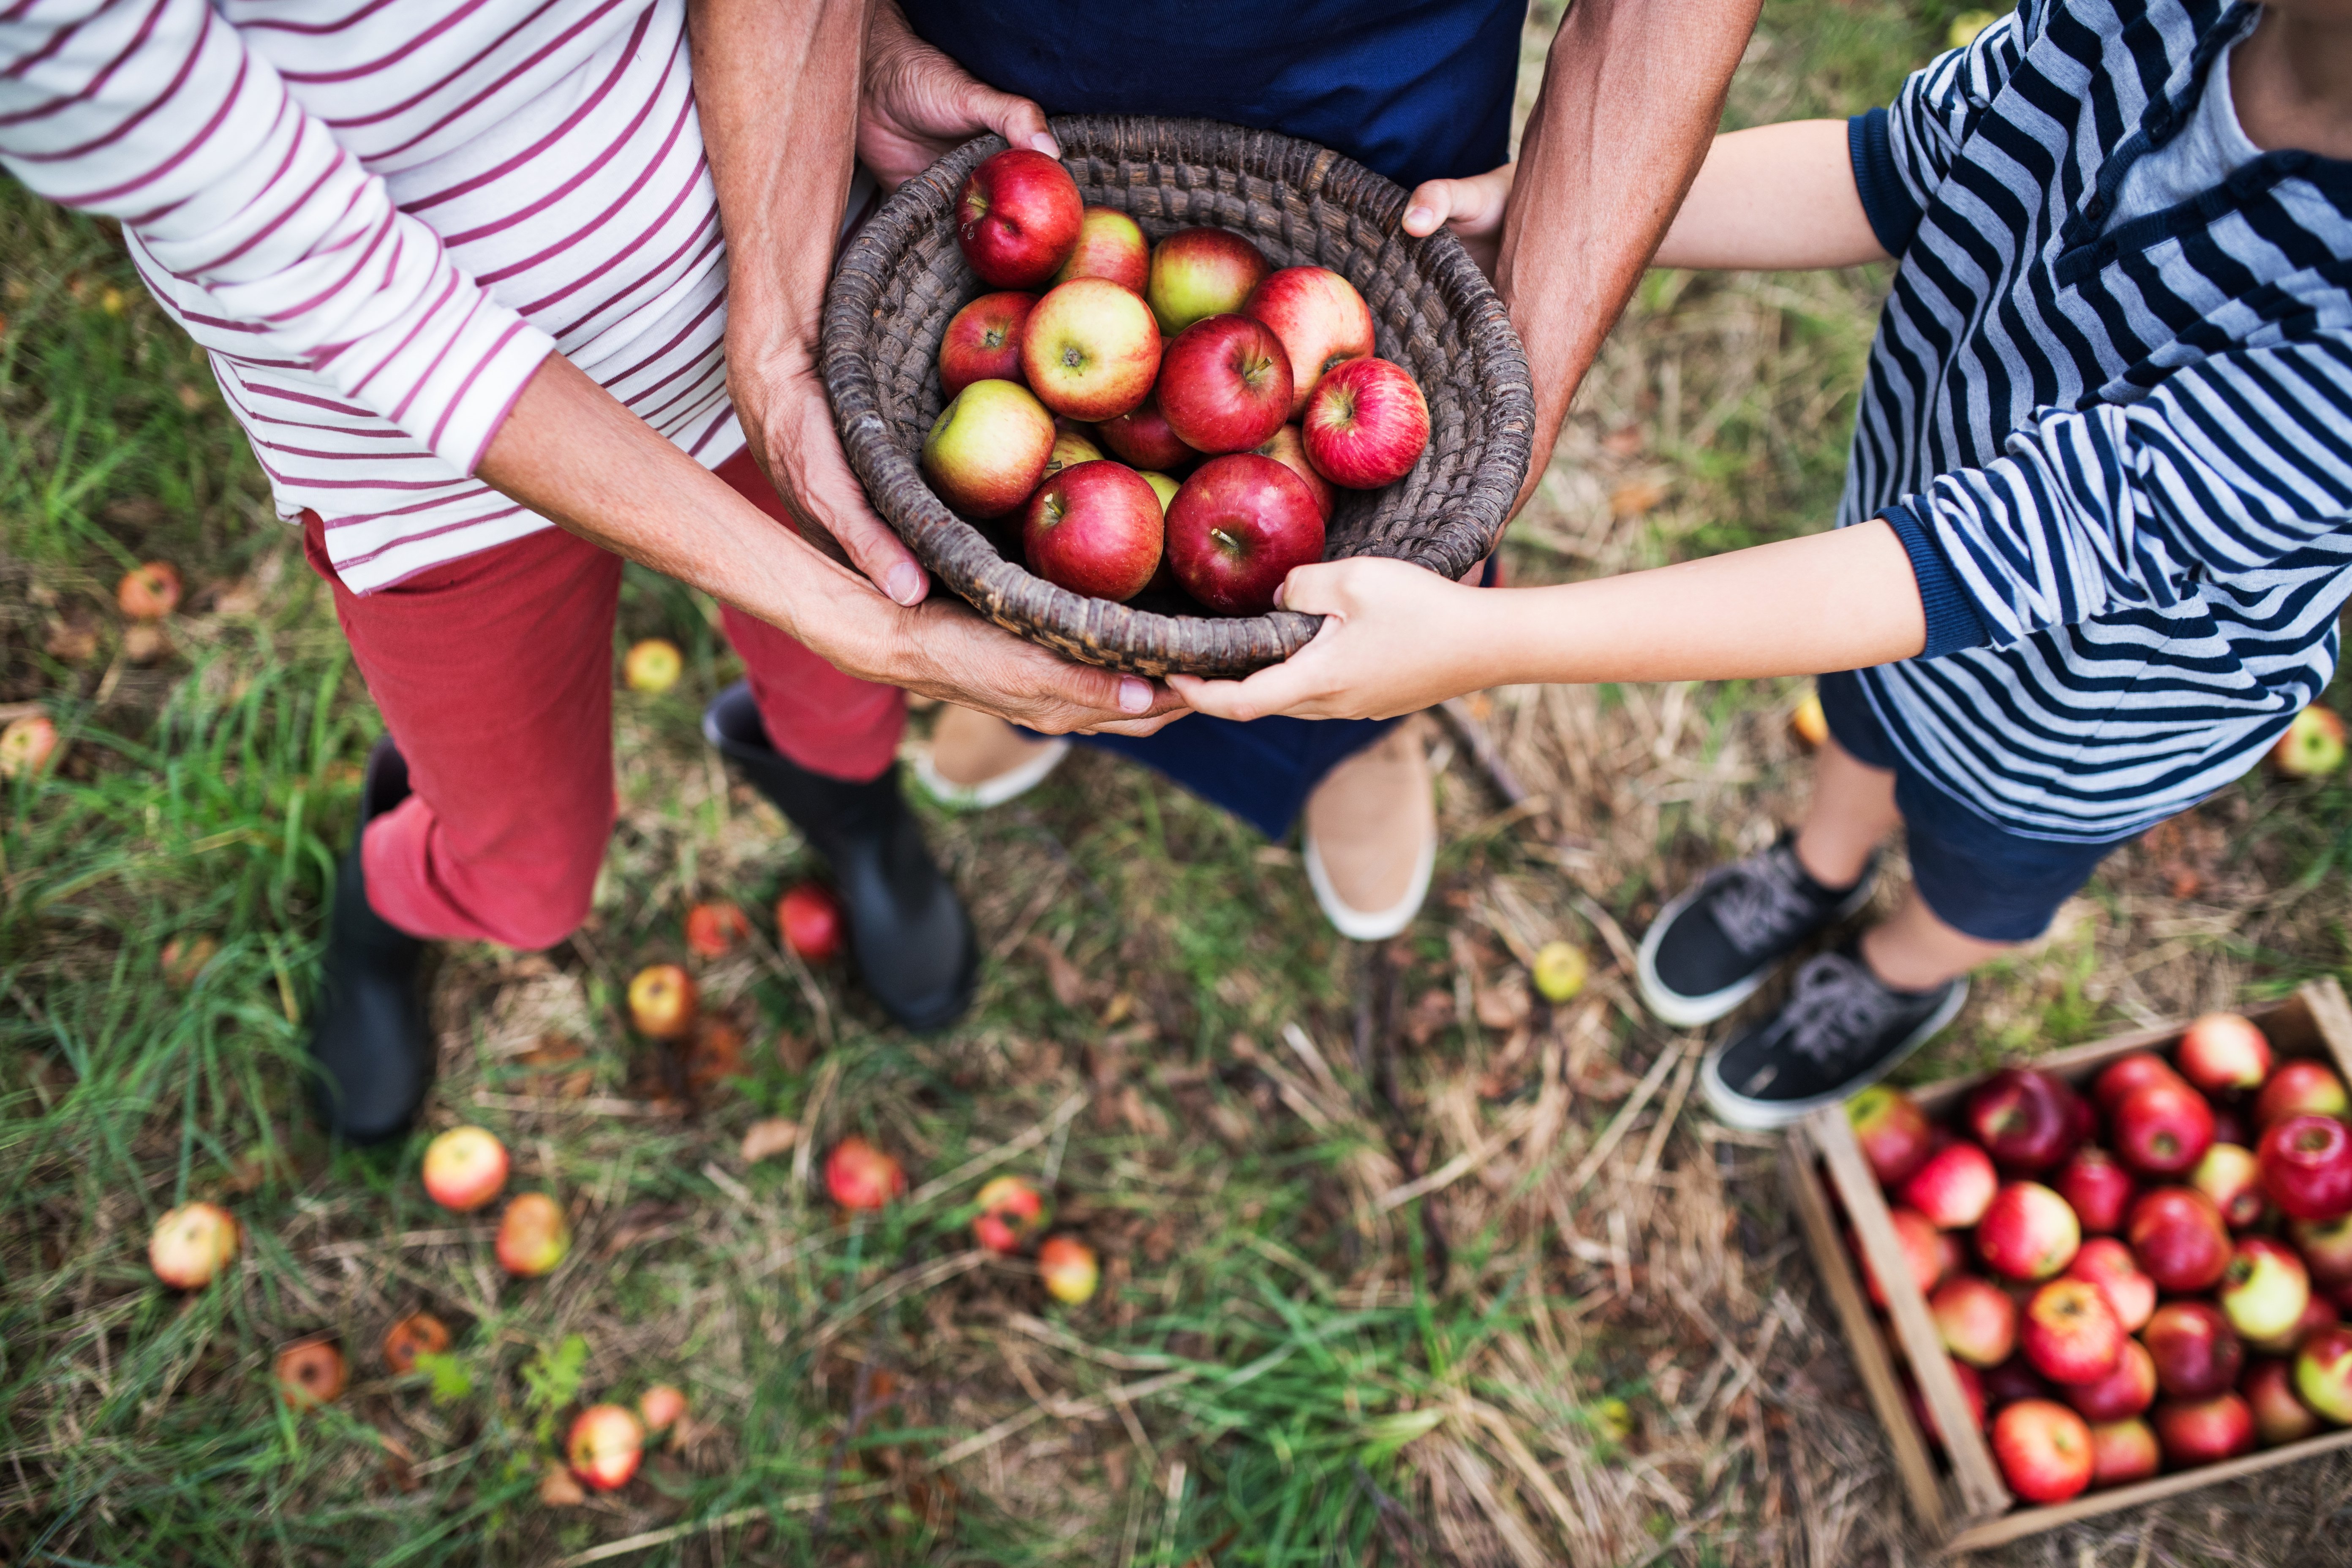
left=0, top=0, right=743, bottom=592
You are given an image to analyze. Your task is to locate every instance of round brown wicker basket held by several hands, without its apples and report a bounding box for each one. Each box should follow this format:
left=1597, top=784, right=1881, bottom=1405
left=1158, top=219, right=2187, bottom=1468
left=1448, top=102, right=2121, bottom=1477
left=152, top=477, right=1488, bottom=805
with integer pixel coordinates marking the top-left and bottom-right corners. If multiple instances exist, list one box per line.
left=823, top=115, right=1536, bottom=675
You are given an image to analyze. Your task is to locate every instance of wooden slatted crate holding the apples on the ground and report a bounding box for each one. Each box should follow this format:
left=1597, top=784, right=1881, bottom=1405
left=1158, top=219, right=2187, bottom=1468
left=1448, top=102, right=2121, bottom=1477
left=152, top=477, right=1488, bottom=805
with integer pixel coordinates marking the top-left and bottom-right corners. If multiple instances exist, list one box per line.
left=1780, top=980, right=2352, bottom=1552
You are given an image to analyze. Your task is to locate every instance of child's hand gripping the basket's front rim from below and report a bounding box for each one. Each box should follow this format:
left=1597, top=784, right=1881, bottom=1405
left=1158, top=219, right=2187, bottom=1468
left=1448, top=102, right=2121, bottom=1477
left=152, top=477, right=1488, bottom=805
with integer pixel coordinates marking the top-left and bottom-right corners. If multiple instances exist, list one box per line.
left=1169, top=555, right=1503, bottom=719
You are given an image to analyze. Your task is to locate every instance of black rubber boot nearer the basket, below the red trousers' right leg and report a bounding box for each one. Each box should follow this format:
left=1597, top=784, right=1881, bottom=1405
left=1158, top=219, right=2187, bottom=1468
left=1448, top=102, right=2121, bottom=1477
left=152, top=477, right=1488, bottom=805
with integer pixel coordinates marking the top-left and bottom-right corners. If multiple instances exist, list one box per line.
left=703, top=682, right=981, bottom=1032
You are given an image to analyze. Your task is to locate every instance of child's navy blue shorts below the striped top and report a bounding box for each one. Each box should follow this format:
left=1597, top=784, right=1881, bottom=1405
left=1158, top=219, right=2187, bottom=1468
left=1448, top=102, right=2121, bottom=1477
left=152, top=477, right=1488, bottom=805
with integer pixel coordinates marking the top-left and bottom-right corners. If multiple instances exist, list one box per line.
left=1818, top=672, right=2138, bottom=943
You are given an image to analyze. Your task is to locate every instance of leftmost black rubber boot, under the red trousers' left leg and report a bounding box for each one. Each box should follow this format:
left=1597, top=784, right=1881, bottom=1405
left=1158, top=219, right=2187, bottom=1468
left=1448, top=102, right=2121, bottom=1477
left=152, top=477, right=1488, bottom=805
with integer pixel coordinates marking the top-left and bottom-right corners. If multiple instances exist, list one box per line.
left=310, top=738, right=433, bottom=1143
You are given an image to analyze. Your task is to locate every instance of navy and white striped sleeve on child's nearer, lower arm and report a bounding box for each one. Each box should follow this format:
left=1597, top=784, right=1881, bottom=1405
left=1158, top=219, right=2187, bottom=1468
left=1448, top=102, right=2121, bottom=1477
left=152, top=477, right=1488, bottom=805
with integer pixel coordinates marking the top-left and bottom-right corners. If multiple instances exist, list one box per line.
left=1881, top=334, right=2352, bottom=656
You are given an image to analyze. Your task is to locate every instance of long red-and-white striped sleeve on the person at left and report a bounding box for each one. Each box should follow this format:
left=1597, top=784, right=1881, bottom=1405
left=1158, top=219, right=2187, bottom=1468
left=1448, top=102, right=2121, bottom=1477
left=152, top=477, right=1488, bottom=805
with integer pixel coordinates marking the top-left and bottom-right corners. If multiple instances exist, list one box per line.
left=0, top=0, right=555, bottom=473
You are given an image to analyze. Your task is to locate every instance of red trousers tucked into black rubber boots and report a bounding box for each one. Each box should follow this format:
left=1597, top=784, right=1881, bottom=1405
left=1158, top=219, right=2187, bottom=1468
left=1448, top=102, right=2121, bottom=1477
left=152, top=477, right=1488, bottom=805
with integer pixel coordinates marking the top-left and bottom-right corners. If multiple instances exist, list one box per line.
left=303, top=454, right=906, bottom=947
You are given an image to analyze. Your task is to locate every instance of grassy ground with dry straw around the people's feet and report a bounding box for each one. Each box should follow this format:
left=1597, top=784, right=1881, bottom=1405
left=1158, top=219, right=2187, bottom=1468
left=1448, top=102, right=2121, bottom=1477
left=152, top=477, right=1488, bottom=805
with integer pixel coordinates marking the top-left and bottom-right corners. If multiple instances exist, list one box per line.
left=0, top=0, right=2352, bottom=1568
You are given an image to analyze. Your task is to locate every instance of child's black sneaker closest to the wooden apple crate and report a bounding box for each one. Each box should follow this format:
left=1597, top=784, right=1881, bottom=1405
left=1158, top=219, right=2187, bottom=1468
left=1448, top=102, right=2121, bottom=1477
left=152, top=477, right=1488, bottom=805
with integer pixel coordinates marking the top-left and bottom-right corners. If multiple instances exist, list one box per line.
left=1698, top=945, right=1968, bottom=1128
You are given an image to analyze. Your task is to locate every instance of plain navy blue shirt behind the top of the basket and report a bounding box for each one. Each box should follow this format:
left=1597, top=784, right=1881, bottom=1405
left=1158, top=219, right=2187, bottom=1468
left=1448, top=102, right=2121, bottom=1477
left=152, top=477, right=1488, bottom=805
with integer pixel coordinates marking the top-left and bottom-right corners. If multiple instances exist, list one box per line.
left=903, top=0, right=1527, bottom=188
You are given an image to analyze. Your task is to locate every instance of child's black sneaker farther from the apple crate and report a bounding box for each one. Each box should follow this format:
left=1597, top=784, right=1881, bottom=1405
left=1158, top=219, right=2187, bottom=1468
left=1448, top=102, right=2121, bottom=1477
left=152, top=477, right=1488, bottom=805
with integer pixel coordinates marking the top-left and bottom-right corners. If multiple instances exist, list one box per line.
left=1635, top=832, right=1879, bottom=1030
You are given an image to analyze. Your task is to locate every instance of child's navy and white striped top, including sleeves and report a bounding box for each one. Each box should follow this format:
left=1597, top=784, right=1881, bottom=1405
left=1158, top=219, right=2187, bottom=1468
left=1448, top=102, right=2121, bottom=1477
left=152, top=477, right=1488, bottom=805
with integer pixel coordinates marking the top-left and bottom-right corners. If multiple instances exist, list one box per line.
left=1839, top=0, right=2352, bottom=841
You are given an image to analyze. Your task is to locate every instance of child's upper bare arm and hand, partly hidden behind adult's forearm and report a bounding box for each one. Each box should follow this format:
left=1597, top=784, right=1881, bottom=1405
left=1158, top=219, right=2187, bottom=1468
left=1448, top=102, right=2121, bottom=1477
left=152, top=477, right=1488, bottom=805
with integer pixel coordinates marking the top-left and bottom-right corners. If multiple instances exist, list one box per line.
left=1404, top=120, right=1886, bottom=270
